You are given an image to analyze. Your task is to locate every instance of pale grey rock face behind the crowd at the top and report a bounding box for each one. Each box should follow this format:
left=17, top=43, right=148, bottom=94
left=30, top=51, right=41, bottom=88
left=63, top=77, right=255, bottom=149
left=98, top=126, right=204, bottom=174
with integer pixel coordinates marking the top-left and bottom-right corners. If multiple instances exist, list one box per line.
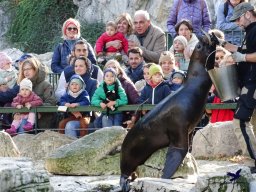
left=73, top=0, right=256, bottom=31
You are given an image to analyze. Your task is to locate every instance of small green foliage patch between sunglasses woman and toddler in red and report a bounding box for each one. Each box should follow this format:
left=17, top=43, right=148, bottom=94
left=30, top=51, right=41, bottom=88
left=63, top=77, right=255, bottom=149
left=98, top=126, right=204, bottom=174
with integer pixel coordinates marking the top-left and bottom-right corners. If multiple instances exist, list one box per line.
left=81, top=22, right=105, bottom=47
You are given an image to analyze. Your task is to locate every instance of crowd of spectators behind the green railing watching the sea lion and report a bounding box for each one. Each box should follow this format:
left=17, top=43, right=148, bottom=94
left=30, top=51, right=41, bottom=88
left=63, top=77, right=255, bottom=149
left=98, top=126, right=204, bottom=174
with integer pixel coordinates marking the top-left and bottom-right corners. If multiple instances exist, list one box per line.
left=0, top=0, right=248, bottom=137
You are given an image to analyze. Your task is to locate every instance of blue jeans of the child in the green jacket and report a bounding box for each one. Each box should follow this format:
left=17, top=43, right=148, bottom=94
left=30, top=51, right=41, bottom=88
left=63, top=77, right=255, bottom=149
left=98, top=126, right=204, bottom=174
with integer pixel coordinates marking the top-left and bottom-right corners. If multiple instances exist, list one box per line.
left=102, top=113, right=123, bottom=127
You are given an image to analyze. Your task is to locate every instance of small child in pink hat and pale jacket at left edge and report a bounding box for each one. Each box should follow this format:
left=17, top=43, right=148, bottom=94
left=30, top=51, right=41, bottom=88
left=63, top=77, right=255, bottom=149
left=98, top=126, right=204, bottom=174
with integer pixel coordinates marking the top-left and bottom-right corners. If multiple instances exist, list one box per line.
left=0, top=52, right=18, bottom=92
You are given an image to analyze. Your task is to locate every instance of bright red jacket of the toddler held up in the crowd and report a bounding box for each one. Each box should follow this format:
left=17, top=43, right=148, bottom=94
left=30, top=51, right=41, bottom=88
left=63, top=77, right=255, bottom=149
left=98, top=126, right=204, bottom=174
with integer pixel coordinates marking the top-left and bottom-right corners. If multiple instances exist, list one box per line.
left=96, top=32, right=128, bottom=54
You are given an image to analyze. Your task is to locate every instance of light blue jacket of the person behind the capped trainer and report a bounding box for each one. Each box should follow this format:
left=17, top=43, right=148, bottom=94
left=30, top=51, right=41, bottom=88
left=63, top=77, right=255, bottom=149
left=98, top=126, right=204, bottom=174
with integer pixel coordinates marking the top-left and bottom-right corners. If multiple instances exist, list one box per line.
left=216, top=3, right=243, bottom=45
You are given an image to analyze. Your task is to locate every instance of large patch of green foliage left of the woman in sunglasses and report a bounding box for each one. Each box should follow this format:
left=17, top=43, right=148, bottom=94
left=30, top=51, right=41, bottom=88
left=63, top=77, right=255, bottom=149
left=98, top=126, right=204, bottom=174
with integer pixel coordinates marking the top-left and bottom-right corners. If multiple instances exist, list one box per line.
left=8, top=0, right=77, bottom=53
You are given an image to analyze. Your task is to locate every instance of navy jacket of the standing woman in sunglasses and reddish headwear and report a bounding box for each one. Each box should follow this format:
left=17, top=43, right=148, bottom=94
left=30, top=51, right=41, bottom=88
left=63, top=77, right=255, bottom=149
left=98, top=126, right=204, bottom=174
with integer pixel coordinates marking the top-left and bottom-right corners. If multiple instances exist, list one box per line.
left=51, top=40, right=96, bottom=73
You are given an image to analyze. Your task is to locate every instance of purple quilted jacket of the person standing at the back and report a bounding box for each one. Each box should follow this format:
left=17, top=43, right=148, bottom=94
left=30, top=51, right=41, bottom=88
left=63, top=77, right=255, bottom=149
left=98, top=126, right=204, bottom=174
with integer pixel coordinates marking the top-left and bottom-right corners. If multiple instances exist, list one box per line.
left=167, top=0, right=211, bottom=37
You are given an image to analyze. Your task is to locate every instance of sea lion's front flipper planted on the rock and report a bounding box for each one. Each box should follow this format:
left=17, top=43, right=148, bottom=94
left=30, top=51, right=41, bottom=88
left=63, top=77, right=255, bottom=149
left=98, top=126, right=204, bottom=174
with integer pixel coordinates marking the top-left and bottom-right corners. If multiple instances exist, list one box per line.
left=162, top=147, right=188, bottom=179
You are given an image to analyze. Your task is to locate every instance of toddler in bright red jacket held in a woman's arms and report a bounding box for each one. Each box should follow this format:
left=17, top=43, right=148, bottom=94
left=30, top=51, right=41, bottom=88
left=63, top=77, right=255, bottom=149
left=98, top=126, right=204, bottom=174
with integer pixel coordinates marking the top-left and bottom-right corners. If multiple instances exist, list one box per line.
left=95, top=21, right=128, bottom=56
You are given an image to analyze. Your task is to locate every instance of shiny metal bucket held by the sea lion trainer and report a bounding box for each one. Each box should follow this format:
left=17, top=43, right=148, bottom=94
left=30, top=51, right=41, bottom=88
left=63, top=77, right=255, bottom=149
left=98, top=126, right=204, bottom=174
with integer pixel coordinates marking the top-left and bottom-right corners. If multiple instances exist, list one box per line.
left=208, top=65, right=240, bottom=101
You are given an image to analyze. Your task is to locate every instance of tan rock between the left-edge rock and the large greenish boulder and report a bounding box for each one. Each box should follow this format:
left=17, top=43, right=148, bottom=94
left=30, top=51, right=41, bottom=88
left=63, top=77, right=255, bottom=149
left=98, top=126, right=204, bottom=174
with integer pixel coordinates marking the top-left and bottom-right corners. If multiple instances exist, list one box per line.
left=13, top=130, right=75, bottom=160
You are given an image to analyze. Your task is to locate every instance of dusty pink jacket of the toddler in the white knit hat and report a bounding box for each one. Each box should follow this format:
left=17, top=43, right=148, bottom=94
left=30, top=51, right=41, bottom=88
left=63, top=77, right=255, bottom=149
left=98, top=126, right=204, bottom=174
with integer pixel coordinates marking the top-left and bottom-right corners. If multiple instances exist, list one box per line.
left=11, top=91, right=43, bottom=107
